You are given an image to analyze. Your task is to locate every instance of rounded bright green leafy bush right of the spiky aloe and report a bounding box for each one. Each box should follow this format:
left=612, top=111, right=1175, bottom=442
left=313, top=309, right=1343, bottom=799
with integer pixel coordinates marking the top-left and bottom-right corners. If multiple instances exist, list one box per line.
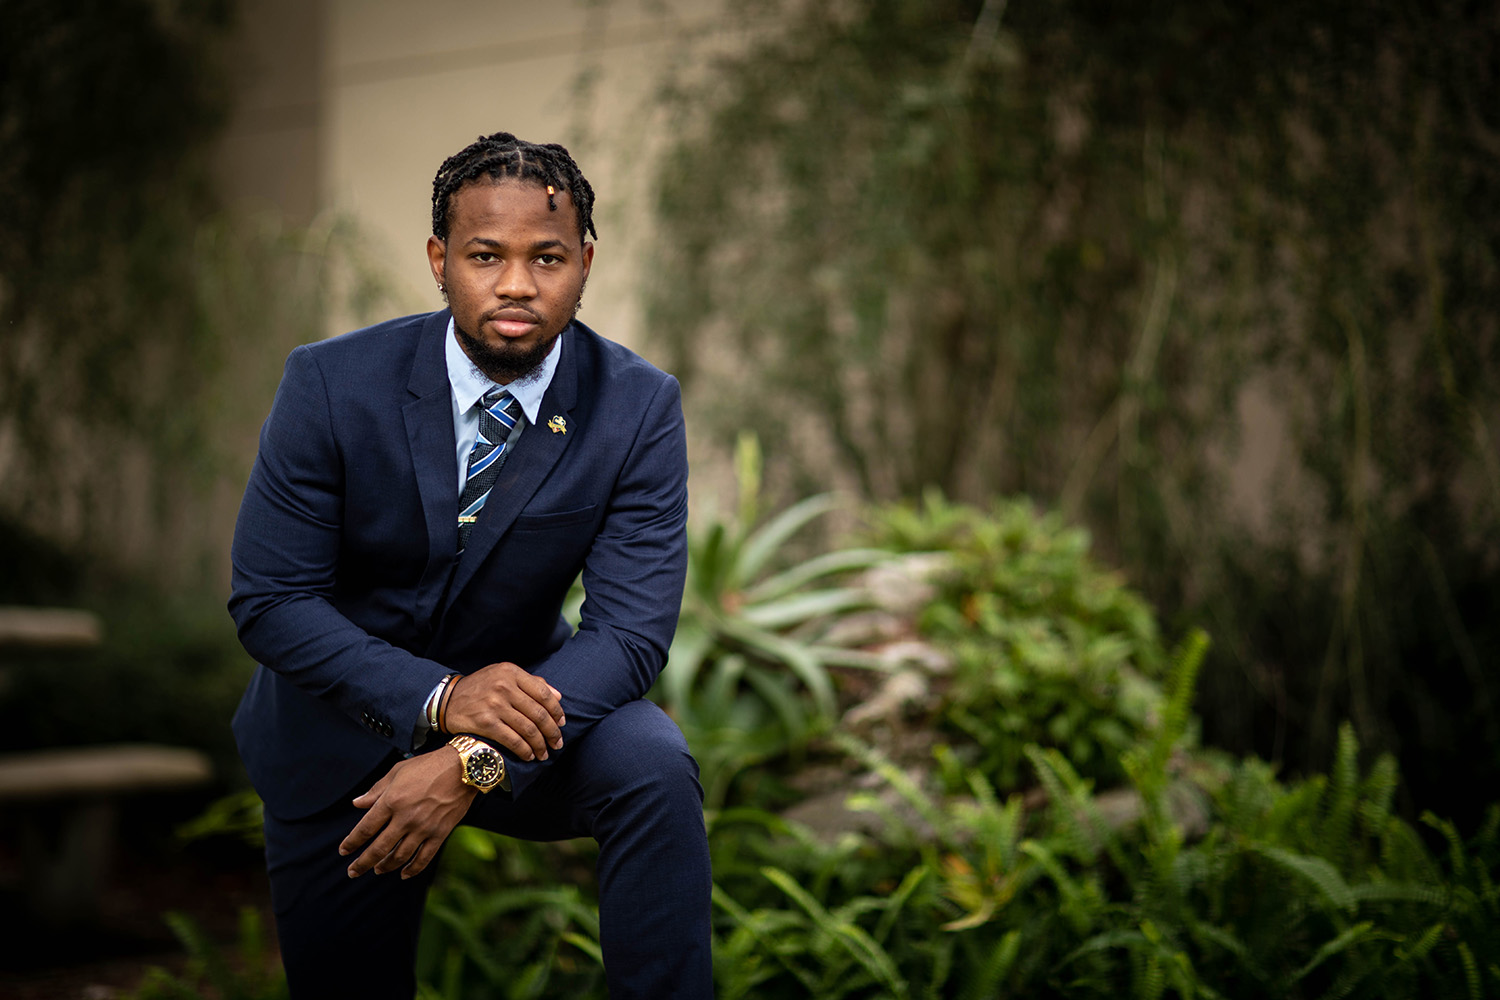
left=872, top=490, right=1185, bottom=789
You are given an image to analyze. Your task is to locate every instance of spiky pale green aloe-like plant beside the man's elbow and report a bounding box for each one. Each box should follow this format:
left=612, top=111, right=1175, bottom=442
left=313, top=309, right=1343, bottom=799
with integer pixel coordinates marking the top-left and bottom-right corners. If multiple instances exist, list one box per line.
left=653, top=436, right=890, bottom=808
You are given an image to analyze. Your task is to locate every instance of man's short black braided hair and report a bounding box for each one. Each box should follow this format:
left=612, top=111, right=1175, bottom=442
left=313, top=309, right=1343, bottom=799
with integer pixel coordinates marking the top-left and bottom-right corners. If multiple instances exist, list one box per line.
left=432, top=132, right=599, bottom=243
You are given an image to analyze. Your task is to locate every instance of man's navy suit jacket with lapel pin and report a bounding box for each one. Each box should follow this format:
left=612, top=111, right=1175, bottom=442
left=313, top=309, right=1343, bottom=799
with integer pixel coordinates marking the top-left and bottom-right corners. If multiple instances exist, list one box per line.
left=230, top=310, right=687, bottom=819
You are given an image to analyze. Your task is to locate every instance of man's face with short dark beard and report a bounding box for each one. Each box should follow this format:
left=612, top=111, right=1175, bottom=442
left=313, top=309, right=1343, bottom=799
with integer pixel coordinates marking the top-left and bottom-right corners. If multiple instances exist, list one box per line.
left=428, top=178, right=594, bottom=385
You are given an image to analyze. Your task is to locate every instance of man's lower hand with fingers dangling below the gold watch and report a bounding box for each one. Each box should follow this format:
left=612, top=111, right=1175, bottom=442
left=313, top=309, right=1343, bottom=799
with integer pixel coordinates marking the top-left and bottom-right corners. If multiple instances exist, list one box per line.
left=339, top=747, right=479, bottom=879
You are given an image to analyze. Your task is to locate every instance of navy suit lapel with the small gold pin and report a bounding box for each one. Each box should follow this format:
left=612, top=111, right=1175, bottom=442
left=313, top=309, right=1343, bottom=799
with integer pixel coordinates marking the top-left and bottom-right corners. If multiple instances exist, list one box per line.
left=446, top=327, right=579, bottom=604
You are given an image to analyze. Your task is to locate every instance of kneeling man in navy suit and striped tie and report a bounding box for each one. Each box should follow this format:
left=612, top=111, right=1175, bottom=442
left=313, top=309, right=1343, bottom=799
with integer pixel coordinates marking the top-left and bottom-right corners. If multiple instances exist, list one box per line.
left=230, top=132, right=713, bottom=1000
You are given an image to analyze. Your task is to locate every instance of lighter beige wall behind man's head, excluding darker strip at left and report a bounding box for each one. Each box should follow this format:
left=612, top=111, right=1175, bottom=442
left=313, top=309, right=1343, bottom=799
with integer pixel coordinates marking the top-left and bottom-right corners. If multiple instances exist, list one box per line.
left=320, top=0, right=732, bottom=345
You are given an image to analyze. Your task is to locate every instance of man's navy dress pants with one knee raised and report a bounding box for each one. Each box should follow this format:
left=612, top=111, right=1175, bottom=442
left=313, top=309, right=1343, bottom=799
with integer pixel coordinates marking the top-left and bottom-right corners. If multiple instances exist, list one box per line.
left=266, top=702, right=713, bottom=1000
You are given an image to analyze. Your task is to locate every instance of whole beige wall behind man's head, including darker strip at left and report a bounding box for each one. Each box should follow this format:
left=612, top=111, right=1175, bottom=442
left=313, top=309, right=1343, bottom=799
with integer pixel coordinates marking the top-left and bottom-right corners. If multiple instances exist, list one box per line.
left=221, top=0, right=735, bottom=346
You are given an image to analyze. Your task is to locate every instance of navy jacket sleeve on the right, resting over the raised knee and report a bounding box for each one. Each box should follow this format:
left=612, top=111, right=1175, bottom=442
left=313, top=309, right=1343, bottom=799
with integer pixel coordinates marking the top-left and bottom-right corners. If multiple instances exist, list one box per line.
left=509, top=375, right=687, bottom=796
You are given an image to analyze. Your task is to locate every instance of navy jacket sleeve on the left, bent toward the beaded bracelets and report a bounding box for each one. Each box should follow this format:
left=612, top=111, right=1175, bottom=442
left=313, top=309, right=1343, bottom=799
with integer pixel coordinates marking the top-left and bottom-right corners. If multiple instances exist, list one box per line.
left=230, top=346, right=446, bottom=751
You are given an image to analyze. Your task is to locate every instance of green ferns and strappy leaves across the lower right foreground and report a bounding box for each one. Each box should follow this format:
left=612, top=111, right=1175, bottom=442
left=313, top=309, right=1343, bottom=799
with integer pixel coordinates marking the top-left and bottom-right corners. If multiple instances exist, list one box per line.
left=713, top=659, right=1500, bottom=999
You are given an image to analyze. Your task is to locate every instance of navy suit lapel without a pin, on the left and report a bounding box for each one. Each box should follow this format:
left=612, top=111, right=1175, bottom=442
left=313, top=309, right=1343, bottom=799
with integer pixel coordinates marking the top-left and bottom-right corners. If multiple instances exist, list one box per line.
left=401, top=309, right=459, bottom=622
